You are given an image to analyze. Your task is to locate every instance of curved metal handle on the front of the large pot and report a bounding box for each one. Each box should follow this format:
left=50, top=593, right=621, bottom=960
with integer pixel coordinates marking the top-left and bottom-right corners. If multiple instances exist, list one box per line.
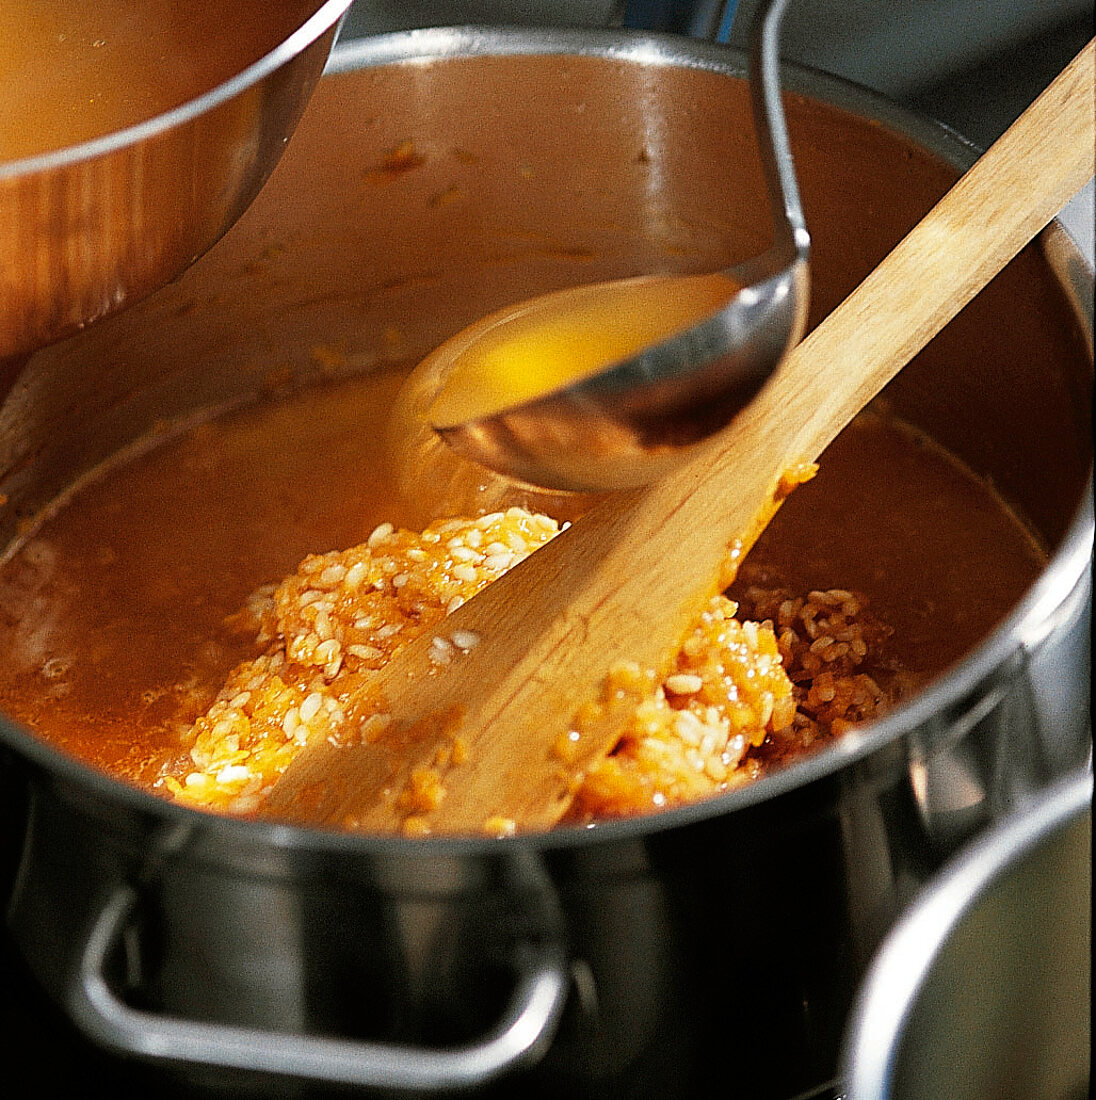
left=68, top=884, right=568, bottom=1090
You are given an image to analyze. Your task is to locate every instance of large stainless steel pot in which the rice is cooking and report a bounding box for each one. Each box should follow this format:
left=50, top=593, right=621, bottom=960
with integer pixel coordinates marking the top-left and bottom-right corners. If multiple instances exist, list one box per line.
left=0, top=30, right=1093, bottom=1100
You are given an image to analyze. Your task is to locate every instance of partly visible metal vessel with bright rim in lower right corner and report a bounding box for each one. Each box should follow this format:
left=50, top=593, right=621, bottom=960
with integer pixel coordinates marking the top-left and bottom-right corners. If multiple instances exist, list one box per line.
left=843, top=772, right=1093, bottom=1100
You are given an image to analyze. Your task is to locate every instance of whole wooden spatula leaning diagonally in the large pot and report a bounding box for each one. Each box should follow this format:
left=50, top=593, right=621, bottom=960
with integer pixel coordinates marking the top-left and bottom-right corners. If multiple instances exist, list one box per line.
left=263, top=40, right=1096, bottom=833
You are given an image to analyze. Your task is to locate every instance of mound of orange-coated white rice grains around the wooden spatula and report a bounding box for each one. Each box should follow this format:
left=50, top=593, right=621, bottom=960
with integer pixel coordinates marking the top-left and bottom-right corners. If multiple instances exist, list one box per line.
left=156, top=508, right=899, bottom=833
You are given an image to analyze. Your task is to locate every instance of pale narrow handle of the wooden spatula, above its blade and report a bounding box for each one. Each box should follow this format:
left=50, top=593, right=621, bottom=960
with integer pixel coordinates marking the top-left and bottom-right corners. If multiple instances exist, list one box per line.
left=789, top=40, right=1096, bottom=468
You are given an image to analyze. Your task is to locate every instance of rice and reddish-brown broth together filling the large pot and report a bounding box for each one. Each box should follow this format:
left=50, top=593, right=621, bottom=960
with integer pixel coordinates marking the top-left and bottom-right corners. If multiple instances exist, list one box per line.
left=0, top=370, right=1046, bottom=834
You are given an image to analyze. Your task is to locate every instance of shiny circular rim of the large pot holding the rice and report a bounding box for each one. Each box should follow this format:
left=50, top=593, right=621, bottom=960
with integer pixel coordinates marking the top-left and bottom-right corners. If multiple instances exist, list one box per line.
left=0, top=23, right=1094, bottom=855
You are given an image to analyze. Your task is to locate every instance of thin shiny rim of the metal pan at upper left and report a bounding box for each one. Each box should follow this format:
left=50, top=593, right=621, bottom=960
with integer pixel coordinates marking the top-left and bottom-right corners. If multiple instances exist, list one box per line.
left=0, top=0, right=352, bottom=183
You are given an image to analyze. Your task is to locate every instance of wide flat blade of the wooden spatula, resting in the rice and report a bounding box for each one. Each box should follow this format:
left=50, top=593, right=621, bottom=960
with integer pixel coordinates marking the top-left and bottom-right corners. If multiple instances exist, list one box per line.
left=263, top=486, right=792, bottom=832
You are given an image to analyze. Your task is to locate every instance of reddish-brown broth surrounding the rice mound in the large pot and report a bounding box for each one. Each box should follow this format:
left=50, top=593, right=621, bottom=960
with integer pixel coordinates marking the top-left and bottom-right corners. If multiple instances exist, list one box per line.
left=0, top=372, right=1045, bottom=784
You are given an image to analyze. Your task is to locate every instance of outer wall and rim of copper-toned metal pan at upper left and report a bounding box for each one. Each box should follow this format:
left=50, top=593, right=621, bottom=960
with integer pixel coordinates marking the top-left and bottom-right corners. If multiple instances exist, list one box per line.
left=0, top=0, right=350, bottom=365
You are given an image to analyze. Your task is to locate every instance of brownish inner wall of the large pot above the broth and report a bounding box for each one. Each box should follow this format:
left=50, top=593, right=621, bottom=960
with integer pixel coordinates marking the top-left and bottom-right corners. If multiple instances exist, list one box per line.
left=0, top=30, right=1092, bottom=827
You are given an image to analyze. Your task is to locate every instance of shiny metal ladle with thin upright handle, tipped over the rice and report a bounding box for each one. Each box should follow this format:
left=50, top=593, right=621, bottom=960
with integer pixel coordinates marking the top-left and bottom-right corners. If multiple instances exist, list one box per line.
left=430, top=0, right=810, bottom=492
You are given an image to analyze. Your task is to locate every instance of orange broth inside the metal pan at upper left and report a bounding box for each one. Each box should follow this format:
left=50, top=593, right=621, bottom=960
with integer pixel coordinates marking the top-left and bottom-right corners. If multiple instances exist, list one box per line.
left=0, top=0, right=322, bottom=163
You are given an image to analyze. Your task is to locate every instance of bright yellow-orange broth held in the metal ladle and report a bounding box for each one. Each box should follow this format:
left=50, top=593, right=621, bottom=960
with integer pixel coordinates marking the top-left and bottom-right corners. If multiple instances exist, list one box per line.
left=424, top=274, right=738, bottom=428
